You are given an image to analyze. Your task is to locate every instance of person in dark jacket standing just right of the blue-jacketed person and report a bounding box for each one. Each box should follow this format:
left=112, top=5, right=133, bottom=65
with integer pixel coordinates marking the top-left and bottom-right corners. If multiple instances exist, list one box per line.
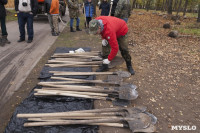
left=99, top=0, right=110, bottom=16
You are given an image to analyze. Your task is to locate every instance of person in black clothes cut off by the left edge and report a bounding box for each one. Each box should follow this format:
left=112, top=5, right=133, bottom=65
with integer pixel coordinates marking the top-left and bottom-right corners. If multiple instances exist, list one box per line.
left=0, top=0, right=10, bottom=46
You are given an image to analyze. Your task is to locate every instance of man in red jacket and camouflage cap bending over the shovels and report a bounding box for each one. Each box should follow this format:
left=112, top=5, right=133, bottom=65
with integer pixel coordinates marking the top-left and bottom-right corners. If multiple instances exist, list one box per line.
left=89, top=16, right=135, bottom=75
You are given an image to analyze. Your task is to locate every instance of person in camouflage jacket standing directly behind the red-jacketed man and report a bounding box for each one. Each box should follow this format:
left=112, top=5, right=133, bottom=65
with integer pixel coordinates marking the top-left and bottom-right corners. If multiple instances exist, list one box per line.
left=114, top=0, right=131, bottom=23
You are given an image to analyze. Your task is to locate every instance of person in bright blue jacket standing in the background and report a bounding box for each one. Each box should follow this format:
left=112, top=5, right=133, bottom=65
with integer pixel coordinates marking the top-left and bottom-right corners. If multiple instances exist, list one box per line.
left=83, top=0, right=94, bottom=28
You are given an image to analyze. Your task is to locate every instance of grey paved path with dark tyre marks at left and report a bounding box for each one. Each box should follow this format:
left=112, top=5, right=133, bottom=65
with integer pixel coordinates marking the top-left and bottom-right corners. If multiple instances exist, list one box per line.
left=0, top=11, right=68, bottom=108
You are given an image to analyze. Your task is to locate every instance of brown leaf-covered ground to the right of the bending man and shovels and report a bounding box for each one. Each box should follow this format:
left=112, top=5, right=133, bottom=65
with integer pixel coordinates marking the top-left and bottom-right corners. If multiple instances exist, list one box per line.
left=127, top=12, right=200, bottom=133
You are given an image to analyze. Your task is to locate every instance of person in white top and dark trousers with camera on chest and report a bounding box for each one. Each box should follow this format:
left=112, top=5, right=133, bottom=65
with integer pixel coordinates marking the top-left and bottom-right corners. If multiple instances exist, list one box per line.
left=15, top=0, right=38, bottom=43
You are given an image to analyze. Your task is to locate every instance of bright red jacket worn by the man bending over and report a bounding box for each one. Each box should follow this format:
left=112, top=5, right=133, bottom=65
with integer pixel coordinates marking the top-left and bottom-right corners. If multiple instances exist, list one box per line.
left=95, top=16, right=128, bottom=61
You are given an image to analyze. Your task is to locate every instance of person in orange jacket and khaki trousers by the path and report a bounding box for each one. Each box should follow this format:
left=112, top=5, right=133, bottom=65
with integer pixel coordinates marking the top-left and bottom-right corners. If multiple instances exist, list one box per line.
left=45, top=0, right=59, bottom=36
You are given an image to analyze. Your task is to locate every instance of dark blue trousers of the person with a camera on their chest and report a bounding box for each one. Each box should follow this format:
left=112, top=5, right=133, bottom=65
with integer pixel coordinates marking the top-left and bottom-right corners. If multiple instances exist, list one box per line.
left=18, top=12, right=34, bottom=40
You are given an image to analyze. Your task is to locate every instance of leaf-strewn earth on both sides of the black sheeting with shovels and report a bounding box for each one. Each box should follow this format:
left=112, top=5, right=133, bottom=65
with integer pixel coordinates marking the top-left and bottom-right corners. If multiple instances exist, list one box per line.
left=0, top=8, right=200, bottom=133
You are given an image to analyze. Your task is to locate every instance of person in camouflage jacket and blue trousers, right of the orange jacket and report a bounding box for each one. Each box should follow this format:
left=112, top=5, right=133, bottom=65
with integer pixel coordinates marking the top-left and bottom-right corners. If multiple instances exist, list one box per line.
left=67, top=0, right=81, bottom=32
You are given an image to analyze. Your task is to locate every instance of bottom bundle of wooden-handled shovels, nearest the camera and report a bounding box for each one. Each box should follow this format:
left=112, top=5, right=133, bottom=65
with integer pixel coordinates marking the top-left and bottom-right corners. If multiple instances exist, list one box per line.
left=17, top=107, right=157, bottom=132
